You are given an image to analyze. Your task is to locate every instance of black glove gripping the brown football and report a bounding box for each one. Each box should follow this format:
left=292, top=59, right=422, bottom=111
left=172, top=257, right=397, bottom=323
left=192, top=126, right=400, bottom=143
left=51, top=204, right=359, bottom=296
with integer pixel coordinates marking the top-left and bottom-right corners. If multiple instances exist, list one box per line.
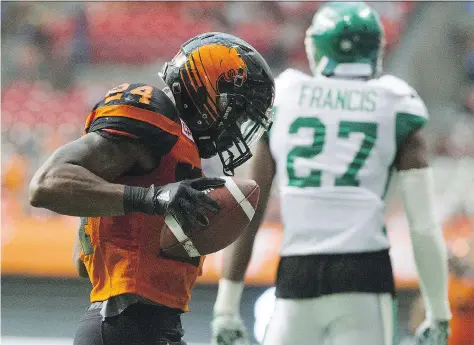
left=123, top=177, right=225, bottom=229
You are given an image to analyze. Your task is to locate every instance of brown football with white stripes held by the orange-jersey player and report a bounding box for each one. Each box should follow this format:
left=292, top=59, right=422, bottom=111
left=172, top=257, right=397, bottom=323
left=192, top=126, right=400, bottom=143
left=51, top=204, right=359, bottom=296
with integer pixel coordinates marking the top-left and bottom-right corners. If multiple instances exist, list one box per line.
left=160, top=177, right=260, bottom=258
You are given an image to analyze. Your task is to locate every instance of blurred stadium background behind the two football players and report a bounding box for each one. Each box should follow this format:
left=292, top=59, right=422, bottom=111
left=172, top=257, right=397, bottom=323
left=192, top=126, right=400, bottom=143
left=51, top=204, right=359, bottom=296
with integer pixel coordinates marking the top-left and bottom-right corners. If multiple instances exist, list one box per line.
left=1, top=1, right=474, bottom=345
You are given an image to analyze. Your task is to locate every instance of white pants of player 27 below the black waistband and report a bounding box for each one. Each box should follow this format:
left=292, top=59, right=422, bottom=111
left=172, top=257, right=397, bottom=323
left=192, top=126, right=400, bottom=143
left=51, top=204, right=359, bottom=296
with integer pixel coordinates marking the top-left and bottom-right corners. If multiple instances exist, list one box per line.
left=256, top=293, right=396, bottom=345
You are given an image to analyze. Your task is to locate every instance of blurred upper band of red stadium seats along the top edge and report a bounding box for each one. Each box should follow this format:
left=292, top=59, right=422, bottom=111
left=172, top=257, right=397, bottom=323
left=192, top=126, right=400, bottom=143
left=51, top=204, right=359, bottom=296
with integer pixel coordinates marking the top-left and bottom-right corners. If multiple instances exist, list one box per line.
left=18, top=1, right=416, bottom=64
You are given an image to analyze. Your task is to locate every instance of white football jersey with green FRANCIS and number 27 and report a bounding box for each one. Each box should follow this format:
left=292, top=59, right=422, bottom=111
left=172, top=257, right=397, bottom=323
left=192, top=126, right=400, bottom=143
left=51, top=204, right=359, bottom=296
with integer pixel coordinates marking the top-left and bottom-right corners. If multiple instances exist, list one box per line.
left=270, top=69, right=428, bottom=255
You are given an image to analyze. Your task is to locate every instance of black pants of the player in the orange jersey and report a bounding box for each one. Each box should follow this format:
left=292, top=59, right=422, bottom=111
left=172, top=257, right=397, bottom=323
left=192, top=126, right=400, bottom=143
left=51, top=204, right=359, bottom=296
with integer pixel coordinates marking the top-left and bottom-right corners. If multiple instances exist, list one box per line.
left=74, top=303, right=186, bottom=345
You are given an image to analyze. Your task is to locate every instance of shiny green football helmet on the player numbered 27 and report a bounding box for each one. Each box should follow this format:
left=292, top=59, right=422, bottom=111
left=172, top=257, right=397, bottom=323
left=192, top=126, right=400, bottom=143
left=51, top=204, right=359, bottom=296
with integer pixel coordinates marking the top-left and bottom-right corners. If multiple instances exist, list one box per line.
left=305, top=2, right=385, bottom=78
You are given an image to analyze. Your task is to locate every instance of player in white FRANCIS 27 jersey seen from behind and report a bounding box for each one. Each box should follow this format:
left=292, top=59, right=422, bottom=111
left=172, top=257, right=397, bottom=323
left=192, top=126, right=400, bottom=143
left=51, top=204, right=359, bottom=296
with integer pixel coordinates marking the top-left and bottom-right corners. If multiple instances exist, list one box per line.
left=212, top=2, right=451, bottom=345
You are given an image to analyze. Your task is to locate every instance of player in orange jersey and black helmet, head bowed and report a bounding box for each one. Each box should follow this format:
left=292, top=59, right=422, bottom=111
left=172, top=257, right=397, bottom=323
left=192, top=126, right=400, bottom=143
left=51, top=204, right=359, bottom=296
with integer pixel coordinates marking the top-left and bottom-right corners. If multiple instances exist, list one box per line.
left=30, top=33, right=274, bottom=345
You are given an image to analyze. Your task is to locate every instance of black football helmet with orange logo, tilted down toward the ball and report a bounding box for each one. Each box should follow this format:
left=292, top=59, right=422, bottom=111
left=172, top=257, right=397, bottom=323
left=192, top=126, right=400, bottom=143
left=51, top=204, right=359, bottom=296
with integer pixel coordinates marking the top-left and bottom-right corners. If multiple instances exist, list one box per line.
left=161, top=32, right=275, bottom=174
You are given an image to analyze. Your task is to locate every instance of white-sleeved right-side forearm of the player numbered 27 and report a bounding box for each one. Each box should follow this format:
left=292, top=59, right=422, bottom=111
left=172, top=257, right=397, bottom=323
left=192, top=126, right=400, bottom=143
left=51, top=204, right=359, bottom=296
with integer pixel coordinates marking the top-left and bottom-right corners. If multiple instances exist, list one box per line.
left=400, top=168, right=451, bottom=320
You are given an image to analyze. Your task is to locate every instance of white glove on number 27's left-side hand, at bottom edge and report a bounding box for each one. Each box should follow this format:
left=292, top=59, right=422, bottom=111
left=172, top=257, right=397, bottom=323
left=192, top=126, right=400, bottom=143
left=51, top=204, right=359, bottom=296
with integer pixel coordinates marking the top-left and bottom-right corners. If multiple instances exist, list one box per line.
left=211, top=314, right=250, bottom=345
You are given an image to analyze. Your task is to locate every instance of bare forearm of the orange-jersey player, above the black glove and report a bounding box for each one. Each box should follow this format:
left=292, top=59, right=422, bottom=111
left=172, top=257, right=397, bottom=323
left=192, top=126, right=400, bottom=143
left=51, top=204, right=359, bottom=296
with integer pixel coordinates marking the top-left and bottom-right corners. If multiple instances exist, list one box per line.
left=30, top=163, right=124, bottom=217
